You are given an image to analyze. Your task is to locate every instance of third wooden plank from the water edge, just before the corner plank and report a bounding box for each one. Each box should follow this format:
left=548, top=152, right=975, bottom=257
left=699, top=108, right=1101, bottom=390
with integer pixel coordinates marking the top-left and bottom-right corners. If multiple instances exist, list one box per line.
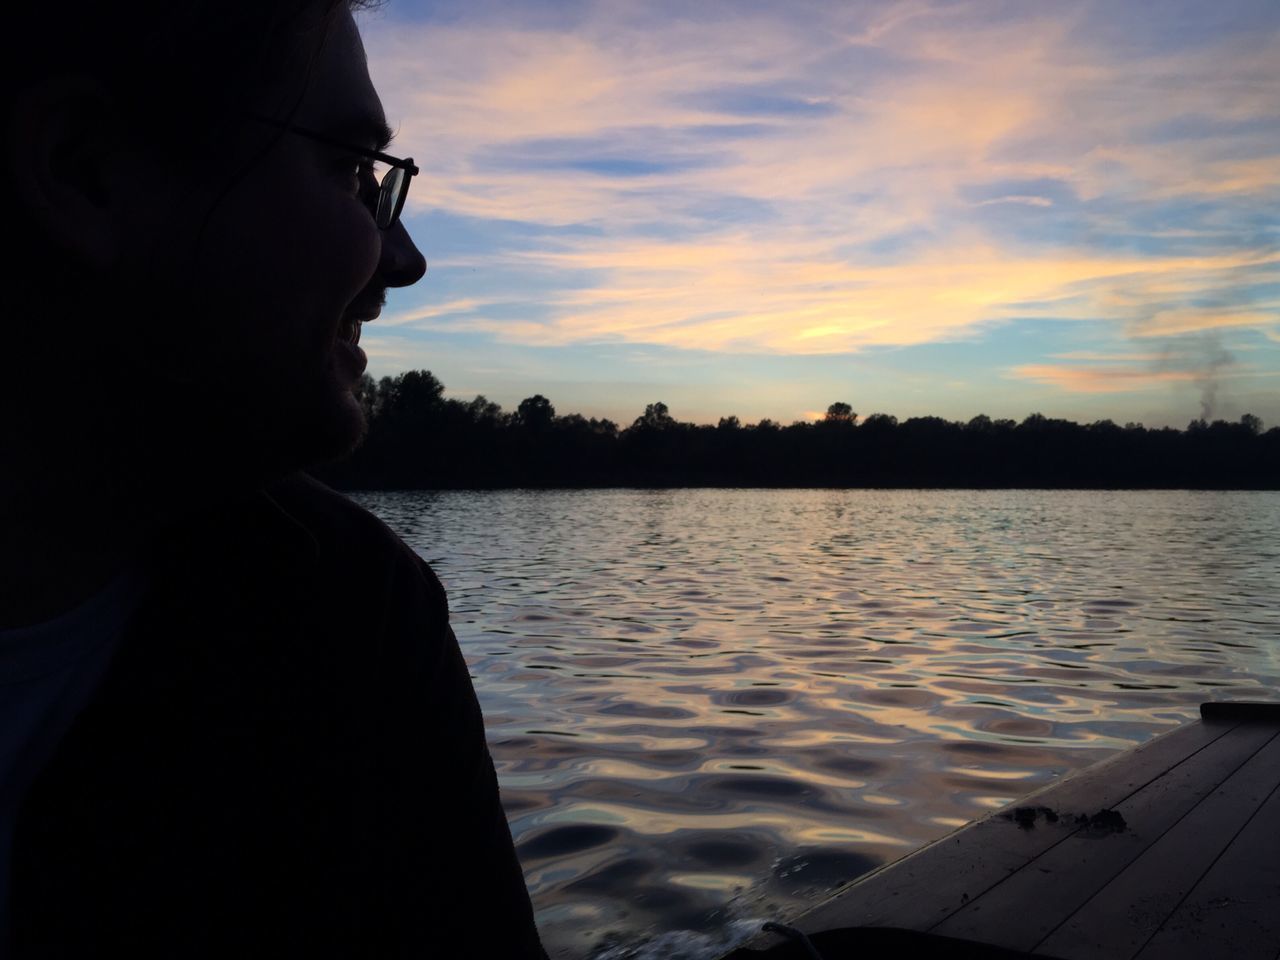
left=1036, top=727, right=1280, bottom=960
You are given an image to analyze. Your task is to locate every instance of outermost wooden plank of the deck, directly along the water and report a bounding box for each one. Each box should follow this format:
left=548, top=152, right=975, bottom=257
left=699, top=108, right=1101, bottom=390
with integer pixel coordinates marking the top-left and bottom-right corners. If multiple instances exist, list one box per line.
left=778, top=723, right=1233, bottom=942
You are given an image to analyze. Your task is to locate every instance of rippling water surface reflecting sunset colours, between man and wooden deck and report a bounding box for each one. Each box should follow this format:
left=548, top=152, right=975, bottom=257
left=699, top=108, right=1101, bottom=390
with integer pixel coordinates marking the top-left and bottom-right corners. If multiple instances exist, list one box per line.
left=356, top=490, right=1280, bottom=957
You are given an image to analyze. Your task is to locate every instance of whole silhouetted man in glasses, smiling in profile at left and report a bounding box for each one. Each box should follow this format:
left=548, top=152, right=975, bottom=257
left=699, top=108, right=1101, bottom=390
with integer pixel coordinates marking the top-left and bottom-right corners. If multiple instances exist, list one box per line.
left=0, top=0, right=544, bottom=959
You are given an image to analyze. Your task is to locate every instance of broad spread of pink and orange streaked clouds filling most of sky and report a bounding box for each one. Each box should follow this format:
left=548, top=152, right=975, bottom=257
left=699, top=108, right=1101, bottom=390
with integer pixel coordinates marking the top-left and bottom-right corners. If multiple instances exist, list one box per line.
left=355, top=1, right=1280, bottom=360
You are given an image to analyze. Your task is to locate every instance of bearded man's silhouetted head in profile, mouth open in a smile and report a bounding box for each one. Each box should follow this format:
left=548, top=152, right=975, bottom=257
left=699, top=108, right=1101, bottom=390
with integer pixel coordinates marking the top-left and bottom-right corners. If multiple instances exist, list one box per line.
left=0, top=0, right=425, bottom=488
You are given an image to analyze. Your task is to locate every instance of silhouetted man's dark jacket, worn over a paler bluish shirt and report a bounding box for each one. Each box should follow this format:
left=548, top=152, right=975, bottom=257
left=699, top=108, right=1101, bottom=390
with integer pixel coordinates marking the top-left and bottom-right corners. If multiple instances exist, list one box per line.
left=12, top=476, right=545, bottom=960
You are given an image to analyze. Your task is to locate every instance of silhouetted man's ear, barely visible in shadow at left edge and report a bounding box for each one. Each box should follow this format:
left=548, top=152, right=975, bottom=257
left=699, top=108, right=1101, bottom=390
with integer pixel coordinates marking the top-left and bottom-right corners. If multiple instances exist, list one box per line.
left=4, top=77, right=125, bottom=270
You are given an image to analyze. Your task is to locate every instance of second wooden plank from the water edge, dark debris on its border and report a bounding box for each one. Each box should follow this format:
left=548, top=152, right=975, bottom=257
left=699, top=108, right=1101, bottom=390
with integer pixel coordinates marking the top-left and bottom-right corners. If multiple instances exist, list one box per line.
left=932, top=723, right=1275, bottom=951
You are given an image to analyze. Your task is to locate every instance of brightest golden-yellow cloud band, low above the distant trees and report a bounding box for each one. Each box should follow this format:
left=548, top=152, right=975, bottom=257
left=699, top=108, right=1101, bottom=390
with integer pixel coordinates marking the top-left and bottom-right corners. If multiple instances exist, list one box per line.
left=481, top=241, right=1280, bottom=353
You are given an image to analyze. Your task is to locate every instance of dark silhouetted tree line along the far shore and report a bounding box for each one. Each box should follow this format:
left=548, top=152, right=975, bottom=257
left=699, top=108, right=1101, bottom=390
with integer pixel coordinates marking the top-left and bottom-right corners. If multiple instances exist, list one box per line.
left=315, top=370, right=1280, bottom=489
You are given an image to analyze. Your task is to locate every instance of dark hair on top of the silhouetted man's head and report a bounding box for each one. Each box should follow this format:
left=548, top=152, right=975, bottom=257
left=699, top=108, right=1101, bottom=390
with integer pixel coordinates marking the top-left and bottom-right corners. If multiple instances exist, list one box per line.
left=0, top=0, right=379, bottom=321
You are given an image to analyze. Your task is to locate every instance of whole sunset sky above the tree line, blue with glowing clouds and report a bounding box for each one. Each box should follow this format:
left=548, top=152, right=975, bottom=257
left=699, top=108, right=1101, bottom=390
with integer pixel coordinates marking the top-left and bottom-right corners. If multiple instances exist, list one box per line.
left=360, top=0, right=1280, bottom=428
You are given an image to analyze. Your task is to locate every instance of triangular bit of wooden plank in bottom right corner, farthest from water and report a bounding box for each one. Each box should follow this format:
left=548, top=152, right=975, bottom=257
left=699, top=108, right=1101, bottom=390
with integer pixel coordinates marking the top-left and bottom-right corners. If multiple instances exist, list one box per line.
left=1137, top=757, right=1280, bottom=960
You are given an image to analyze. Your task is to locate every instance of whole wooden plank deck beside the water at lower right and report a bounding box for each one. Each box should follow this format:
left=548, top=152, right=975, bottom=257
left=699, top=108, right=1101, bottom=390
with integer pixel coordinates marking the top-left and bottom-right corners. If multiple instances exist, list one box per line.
left=728, top=704, right=1280, bottom=960
